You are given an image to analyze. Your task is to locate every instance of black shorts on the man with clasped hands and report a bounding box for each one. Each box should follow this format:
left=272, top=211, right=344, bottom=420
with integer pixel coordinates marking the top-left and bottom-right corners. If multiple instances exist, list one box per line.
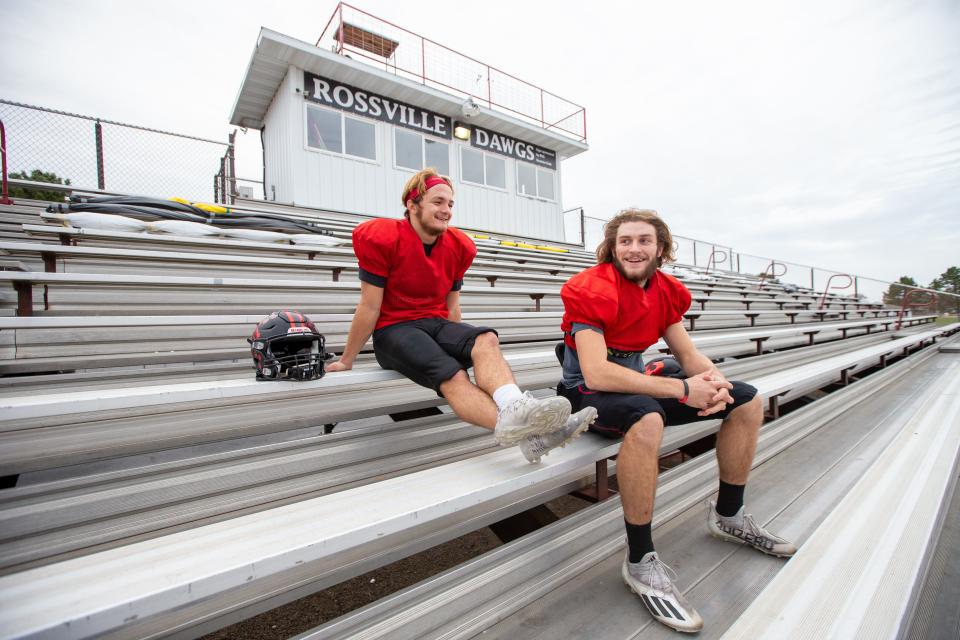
left=557, top=380, right=757, bottom=438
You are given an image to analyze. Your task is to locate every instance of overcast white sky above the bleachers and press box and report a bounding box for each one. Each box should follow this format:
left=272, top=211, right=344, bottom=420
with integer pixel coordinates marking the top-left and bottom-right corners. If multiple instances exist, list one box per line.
left=0, top=0, right=960, bottom=292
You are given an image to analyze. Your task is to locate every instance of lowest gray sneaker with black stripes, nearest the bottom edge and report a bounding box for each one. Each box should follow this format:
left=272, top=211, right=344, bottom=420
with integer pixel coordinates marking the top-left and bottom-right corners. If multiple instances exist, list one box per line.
left=621, top=551, right=703, bottom=633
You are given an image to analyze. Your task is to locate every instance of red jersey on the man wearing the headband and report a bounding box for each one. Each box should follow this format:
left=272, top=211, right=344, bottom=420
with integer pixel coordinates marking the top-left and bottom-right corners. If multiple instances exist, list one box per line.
left=353, top=218, right=477, bottom=329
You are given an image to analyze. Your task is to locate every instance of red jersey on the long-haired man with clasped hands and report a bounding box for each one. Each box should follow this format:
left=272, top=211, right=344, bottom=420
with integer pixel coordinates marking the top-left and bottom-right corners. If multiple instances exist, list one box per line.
left=560, top=262, right=690, bottom=351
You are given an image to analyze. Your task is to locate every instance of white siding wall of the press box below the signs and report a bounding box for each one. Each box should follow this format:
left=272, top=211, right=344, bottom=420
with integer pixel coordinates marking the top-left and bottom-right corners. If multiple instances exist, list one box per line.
left=264, top=67, right=564, bottom=241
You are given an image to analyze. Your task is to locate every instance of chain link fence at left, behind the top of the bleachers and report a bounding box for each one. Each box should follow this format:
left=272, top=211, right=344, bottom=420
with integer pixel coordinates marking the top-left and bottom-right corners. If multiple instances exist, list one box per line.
left=0, top=99, right=233, bottom=202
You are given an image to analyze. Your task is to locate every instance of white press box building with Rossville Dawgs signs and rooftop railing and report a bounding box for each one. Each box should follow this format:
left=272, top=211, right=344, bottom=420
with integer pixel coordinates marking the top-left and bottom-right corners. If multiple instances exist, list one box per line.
left=230, top=11, right=587, bottom=242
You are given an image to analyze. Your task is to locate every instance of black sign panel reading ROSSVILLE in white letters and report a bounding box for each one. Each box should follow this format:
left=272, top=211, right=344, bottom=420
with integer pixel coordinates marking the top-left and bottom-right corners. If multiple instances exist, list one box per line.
left=303, top=71, right=453, bottom=140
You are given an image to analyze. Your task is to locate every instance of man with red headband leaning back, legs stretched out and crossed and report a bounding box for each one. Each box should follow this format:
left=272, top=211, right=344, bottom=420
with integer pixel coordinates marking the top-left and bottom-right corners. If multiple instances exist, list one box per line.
left=326, top=169, right=596, bottom=462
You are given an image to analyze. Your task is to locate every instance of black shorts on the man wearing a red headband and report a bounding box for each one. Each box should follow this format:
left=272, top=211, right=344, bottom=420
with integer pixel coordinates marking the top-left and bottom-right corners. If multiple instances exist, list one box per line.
left=373, top=318, right=496, bottom=396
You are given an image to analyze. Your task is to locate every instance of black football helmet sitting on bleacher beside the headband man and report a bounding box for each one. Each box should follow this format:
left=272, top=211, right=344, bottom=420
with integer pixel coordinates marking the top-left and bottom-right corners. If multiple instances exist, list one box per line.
left=247, top=310, right=329, bottom=380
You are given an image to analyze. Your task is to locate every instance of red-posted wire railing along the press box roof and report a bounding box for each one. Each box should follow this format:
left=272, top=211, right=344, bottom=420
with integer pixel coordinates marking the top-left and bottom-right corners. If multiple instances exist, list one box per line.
left=316, top=2, right=587, bottom=142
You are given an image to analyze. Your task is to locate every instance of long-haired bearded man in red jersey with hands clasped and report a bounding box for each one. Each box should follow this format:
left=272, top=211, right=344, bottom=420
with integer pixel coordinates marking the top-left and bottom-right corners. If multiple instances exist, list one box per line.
left=557, top=209, right=796, bottom=632
